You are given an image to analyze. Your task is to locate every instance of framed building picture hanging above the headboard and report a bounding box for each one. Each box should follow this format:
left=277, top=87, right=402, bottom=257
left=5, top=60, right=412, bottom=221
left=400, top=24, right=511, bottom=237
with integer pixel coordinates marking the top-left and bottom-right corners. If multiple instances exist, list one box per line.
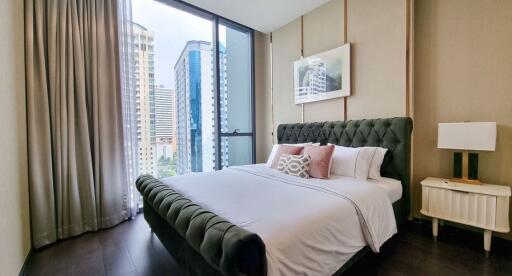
left=293, top=44, right=350, bottom=104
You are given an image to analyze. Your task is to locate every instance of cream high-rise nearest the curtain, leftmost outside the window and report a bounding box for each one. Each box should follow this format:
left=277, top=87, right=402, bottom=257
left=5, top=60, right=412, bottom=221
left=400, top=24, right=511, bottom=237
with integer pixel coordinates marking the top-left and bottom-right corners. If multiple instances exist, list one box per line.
left=132, top=23, right=156, bottom=174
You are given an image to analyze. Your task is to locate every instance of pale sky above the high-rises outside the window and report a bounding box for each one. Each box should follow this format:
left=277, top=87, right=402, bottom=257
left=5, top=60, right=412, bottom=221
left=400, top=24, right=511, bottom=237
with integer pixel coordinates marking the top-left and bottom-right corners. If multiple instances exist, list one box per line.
left=132, top=0, right=214, bottom=89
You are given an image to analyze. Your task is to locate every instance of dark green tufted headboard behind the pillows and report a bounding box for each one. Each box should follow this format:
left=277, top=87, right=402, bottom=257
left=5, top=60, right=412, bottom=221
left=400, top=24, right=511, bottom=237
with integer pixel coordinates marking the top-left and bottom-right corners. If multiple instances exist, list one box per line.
left=277, top=117, right=412, bottom=222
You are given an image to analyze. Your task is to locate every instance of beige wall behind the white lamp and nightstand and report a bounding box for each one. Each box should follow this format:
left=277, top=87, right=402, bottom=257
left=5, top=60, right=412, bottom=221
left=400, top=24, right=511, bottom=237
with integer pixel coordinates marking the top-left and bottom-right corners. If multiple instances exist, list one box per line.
left=413, top=0, right=512, bottom=239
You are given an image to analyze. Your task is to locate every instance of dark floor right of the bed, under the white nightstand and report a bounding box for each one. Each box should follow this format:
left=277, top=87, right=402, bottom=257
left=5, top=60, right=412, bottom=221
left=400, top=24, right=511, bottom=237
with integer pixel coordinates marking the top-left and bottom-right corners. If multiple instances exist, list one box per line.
left=348, top=223, right=512, bottom=276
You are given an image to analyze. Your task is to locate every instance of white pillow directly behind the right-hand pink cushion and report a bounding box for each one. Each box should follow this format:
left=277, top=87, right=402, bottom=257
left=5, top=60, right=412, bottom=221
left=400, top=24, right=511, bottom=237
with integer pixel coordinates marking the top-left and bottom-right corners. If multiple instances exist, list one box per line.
left=331, top=146, right=375, bottom=180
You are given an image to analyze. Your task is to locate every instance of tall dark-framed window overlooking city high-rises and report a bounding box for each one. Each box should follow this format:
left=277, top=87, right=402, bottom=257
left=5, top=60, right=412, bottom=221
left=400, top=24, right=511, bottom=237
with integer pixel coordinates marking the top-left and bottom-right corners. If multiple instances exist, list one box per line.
left=132, top=0, right=254, bottom=177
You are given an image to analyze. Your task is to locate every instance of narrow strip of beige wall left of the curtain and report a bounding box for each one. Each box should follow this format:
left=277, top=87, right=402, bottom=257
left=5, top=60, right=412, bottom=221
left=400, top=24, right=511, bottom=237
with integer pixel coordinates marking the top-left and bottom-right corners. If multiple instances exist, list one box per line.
left=0, top=0, right=30, bottom=275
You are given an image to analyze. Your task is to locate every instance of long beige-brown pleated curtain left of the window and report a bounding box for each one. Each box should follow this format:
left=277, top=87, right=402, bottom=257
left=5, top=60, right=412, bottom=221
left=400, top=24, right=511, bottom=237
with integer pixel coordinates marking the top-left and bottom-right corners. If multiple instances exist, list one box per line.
left=25, top=0, right=129, bottom=248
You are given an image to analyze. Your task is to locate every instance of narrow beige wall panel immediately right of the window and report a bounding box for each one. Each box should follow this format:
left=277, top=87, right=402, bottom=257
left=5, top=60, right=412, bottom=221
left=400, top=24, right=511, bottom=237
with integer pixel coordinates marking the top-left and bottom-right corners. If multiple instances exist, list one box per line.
left=254, top=31, right=273, bottom=163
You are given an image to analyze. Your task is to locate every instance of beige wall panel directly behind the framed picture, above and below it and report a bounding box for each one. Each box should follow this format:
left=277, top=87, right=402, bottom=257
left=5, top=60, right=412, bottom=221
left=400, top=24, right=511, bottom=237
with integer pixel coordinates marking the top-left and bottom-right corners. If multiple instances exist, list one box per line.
left=304, top=0, right=344, bottom=122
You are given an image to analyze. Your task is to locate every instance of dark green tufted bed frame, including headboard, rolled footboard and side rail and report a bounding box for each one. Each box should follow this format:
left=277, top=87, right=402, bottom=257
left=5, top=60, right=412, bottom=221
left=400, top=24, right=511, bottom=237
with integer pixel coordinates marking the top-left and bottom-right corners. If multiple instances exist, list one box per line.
left=136, top=117, right=412, bottom=275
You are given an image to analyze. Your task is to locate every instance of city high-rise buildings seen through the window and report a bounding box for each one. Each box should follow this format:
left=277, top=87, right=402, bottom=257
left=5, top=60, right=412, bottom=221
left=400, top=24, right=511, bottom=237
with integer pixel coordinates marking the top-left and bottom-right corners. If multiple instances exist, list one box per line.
left=132, top=18, right=220, bottom=177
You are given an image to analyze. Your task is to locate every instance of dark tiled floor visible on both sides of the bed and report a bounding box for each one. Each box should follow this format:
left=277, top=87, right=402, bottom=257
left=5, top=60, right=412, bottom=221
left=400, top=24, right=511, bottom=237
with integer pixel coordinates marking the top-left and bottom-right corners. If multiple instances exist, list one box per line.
left=27, top=215, right=512, bottom=276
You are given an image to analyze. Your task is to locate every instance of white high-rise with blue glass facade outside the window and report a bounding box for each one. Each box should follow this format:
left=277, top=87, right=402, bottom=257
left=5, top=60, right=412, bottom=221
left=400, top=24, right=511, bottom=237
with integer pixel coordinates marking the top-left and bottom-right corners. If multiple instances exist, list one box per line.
left=174, top=40, right=216, bottom=174
